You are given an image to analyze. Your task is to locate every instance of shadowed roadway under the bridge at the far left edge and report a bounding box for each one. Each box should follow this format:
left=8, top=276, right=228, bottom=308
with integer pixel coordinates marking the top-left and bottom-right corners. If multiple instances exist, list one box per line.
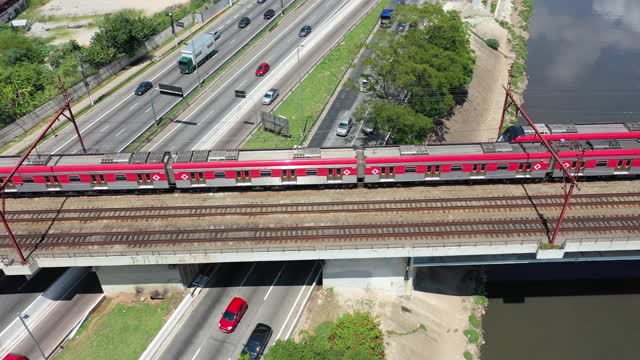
left=0, top=268, right=66, bottom=333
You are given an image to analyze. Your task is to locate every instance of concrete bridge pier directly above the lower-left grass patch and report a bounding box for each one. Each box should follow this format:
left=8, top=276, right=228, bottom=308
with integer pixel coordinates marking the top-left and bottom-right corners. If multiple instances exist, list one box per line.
left=95, top=264, right=200, bottom=295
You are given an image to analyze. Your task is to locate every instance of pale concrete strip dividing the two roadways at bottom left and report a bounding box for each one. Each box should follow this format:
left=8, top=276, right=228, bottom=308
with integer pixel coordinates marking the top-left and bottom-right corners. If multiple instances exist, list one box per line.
left=0, top=267, right=91, bottom=357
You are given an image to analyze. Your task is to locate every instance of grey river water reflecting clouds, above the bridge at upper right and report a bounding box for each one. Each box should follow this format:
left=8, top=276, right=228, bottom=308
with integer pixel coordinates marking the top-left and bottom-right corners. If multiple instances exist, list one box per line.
left=524, top=0, right=640, bottom=123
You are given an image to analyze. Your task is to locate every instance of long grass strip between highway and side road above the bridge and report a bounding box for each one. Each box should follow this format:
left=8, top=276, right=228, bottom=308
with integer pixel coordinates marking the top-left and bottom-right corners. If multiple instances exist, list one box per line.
left=243, top=0, right=389, bottom=149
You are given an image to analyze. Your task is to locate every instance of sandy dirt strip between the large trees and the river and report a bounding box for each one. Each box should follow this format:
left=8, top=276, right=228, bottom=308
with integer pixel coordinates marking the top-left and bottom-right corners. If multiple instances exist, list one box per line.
left=437, top=0, right=515, bottom=143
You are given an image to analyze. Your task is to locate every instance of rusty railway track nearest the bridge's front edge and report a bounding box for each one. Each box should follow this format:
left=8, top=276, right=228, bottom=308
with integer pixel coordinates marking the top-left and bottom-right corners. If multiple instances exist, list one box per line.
left=0, top=216, right=640, bottom=249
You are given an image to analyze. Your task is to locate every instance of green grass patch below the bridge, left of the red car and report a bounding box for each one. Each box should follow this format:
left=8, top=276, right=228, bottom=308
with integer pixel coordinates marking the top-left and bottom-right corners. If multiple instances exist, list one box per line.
left=55, top=295, right=179, bottom=360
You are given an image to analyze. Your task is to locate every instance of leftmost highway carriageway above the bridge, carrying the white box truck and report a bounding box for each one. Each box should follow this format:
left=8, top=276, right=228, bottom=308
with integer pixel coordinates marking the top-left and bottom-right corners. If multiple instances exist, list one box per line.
left=38, top=0, right=292, bottom=153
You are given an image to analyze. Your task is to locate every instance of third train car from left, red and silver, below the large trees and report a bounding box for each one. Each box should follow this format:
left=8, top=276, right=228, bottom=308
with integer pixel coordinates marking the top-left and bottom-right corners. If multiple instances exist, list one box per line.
left=364, top=143, right=552, bottom=183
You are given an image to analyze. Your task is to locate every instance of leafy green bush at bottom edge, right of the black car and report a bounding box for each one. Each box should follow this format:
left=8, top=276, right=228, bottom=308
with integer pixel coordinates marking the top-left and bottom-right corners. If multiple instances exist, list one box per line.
left=265, top=312, right=384, bottom=360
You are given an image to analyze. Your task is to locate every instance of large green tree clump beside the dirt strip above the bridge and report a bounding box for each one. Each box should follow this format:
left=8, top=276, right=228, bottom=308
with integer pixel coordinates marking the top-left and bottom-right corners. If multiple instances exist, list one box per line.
left=355, top=3, right=475, bottom=144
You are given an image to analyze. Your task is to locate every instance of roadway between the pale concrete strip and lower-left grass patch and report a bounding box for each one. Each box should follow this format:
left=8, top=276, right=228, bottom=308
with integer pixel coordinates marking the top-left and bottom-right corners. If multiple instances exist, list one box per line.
left=3, top=271, right=103, bottom=359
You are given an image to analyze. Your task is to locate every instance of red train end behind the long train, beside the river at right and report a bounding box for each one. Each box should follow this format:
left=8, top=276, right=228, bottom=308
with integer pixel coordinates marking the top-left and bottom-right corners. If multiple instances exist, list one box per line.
left=498, top=122, right=640, bottom=142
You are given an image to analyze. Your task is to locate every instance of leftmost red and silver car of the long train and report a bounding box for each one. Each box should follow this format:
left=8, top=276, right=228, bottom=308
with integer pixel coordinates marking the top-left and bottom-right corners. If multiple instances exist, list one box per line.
left=0, top=152, right=170, bottom=193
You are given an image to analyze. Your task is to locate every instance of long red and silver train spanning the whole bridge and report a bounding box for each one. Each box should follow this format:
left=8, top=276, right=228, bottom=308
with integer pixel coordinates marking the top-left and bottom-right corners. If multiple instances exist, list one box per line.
left=0, top=139, right=640, bottom=193
